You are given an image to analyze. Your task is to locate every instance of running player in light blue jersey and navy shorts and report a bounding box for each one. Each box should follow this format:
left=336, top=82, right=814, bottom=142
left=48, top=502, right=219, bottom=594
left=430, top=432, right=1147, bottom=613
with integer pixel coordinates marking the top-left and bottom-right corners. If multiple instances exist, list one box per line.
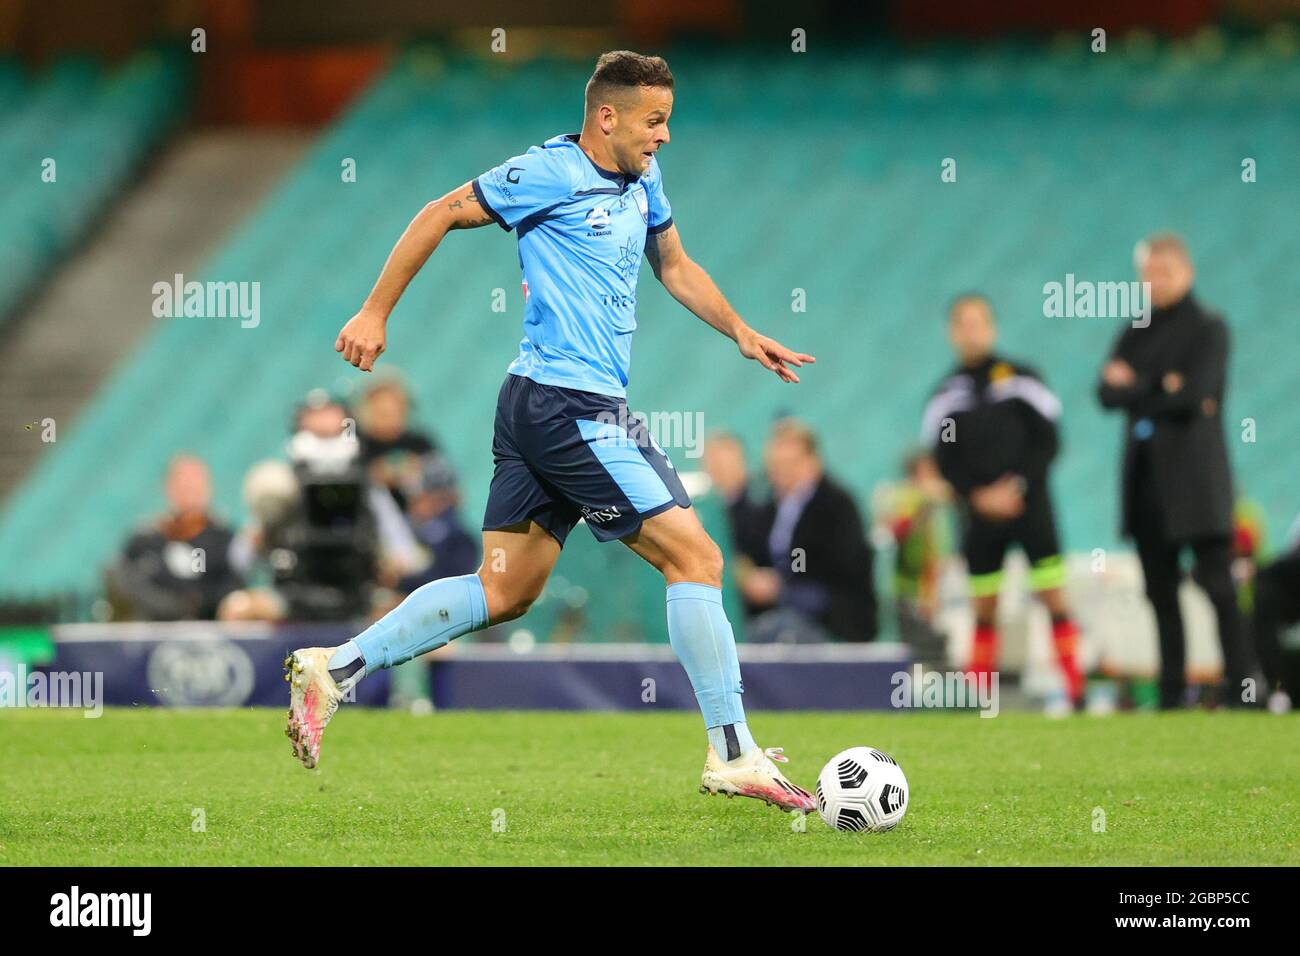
left=285, top=51, right=814, bottom=812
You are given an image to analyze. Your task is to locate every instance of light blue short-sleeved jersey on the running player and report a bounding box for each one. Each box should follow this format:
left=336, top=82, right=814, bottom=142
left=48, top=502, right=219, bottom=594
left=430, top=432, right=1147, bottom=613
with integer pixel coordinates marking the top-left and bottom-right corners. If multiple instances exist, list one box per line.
left=473, top=133, right=672, bottom=398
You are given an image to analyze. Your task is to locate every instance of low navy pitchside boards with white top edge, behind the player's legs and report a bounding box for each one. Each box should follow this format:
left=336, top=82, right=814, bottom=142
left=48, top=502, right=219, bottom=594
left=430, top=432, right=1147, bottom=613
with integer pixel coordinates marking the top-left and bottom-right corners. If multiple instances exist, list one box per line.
left=43, top=622, right=910, bottom=710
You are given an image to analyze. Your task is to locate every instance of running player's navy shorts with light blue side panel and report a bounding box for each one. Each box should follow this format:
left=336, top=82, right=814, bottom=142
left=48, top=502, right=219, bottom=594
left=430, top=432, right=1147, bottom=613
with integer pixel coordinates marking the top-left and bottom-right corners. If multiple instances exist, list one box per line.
left=484, top=375, right=690, bottom=545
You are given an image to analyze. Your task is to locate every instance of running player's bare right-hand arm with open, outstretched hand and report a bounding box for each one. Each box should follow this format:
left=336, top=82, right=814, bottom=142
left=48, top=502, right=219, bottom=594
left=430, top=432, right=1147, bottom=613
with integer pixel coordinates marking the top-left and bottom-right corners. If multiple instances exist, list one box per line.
left=646, top=226, right=816, bottom=382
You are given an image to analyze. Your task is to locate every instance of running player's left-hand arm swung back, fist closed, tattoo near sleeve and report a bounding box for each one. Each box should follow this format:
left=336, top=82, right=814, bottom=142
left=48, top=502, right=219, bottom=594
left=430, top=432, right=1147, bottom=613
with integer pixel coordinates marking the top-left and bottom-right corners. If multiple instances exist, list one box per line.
left=334, top=182, right=493, bottom=372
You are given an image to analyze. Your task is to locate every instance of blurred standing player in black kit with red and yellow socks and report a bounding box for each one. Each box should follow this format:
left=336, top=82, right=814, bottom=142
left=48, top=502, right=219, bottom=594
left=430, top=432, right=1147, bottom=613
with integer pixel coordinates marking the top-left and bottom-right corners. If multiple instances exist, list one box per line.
left=922, top=293, right=1083, bottom=710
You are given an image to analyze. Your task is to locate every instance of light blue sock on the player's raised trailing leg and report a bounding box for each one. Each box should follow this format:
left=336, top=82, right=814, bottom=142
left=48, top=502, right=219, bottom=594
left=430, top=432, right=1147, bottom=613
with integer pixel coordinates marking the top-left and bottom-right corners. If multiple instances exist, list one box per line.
left=329, top=574, right=488, bottom=676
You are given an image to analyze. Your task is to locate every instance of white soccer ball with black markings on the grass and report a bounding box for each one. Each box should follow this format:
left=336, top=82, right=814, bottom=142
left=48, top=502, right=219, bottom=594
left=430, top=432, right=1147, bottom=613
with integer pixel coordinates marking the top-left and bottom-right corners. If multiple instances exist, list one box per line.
left=816, top=747, right=907, bottom=834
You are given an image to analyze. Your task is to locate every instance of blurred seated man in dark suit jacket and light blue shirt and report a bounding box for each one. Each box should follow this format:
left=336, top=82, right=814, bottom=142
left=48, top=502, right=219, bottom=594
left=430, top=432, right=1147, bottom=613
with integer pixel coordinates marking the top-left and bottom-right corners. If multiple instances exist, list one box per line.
left=737, top=419, right=876, bottom=643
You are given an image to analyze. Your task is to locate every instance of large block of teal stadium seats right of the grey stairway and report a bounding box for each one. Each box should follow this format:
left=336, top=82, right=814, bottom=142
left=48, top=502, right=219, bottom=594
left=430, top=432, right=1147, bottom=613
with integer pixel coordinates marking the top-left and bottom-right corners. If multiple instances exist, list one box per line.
left=0, top=36, right=1300, bottom=640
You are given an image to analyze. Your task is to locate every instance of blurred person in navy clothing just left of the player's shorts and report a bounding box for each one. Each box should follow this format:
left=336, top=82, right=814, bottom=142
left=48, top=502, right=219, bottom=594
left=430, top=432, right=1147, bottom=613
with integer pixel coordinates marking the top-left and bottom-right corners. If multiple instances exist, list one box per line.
left=398, top=454, right=478, bottom=593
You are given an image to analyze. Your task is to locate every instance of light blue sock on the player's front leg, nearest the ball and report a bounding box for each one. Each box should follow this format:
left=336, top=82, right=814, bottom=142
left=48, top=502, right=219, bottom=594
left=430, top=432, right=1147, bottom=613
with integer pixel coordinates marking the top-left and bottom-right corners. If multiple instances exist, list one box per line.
left=668, top=581, right=755, bottom=760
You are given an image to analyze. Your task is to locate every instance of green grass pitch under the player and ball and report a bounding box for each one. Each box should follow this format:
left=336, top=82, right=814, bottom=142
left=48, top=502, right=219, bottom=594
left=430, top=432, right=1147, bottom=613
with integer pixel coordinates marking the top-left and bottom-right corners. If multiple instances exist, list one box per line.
left=0, top=708, right=1300, bottom=866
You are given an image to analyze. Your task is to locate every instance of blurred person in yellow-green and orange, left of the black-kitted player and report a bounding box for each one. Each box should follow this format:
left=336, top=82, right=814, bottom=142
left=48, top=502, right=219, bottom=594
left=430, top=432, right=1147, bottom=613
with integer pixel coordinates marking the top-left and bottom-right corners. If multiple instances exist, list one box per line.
left=876, top=450, right=952, bottom=663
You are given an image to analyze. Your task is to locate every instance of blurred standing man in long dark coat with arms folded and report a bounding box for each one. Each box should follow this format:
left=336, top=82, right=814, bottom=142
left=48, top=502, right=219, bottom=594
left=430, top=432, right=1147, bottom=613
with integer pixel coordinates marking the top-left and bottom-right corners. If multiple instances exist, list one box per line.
left=1097, top=233, right=1249, bottom=708
